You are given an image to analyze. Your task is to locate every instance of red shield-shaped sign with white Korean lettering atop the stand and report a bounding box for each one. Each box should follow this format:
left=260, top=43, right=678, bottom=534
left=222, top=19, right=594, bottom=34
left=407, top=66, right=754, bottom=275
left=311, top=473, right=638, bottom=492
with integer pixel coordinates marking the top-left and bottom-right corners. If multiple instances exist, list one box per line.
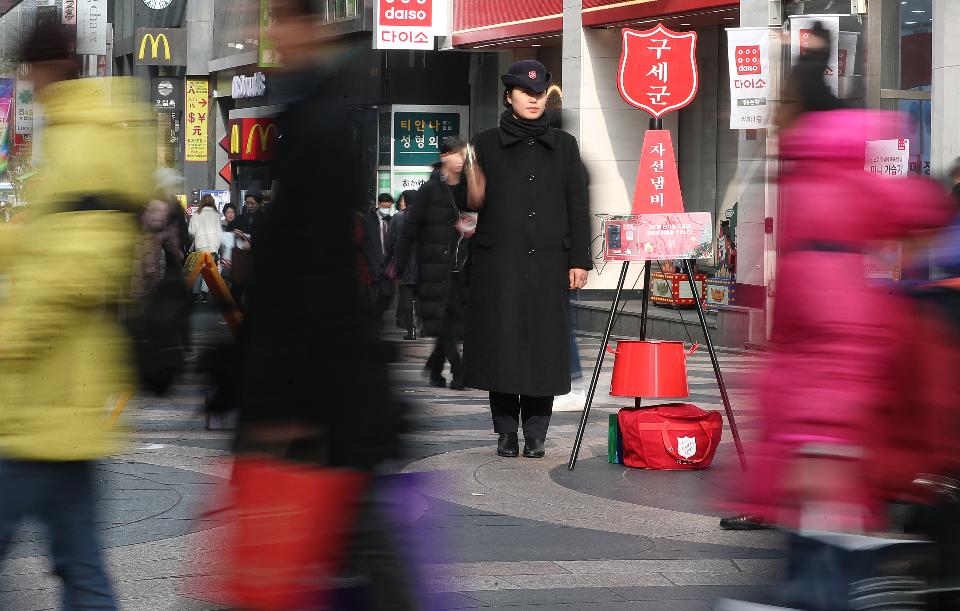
left=617, top=24, right=698, bottom=117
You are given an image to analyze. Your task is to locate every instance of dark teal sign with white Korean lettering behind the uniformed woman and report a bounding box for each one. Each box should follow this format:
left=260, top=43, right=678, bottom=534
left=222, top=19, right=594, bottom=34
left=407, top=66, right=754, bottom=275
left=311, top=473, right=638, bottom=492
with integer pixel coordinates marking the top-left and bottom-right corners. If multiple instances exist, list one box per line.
left=393, top=112, right=460, bottom=166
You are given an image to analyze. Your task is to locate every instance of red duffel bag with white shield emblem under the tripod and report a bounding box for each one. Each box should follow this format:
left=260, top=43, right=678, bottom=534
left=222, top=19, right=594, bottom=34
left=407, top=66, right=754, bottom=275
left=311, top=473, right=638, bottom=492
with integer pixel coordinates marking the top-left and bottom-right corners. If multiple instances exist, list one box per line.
left=618, top=403, right=723, bottom=471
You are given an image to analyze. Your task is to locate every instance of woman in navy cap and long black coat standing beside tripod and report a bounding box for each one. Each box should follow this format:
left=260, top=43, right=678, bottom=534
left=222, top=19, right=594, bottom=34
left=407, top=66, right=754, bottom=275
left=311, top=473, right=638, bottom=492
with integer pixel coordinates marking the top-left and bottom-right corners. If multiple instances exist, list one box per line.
left=464, top=60, right=592, bottom=458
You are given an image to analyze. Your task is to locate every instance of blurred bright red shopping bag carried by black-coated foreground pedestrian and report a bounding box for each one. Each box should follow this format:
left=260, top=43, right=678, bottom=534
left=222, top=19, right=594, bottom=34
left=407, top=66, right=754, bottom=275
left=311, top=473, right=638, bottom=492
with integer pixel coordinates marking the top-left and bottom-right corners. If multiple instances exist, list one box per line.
left=194, top=457, right=368, bottom=611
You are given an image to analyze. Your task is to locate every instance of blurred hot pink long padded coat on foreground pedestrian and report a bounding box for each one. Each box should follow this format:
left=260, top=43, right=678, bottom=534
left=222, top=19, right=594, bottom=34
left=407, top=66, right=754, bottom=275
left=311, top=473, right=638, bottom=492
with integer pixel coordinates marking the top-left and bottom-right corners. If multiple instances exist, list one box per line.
left=735, top=110, right=952, bottom=526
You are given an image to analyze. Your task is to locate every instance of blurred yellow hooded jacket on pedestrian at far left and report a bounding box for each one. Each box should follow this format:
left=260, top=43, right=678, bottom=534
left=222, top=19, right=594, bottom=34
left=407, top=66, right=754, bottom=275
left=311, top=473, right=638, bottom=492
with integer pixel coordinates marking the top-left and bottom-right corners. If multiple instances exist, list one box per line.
left=0, top=78, right=155, bottom=460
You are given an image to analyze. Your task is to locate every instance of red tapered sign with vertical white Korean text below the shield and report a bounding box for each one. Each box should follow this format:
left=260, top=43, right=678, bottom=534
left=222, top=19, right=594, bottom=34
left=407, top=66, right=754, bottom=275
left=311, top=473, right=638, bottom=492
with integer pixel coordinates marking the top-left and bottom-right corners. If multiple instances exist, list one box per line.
left=632, top=129, right=684, bottom=214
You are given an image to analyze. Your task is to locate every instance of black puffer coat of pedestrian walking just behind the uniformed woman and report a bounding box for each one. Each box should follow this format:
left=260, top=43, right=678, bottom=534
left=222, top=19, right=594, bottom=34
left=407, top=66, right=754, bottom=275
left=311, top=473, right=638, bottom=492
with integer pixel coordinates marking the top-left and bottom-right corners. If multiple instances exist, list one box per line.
left=399, top=170, right=469, bottom=337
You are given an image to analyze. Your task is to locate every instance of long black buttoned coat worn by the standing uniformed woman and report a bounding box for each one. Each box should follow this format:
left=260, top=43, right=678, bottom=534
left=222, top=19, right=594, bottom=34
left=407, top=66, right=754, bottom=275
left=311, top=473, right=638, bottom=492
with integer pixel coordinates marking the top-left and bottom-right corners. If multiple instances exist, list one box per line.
left=464, top=128, right=592, bottom=397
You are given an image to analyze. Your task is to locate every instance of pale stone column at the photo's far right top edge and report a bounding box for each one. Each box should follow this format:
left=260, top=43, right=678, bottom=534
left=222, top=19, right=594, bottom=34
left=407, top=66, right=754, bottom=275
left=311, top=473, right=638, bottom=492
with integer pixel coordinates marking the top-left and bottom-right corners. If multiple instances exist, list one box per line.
left=930, top=0, right=960, bottom=175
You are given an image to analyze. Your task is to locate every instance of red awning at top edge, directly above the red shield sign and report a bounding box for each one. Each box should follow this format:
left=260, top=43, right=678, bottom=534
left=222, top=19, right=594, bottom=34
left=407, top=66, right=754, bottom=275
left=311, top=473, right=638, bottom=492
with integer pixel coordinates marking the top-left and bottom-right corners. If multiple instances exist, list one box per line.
left=583, top=0, right=740, bottom=26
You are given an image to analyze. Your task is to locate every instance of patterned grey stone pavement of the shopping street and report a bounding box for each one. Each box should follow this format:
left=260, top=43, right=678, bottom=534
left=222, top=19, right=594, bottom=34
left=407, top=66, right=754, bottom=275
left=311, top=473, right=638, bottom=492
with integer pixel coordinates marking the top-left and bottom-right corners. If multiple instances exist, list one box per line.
left=0, top=312, right=782, bottom=611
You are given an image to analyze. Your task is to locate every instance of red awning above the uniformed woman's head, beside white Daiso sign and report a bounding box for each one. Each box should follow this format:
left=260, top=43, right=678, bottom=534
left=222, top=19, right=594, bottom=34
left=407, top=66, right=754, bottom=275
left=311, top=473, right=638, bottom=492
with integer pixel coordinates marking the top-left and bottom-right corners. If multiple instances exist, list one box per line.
left=453, top=0, right=563, bottom=47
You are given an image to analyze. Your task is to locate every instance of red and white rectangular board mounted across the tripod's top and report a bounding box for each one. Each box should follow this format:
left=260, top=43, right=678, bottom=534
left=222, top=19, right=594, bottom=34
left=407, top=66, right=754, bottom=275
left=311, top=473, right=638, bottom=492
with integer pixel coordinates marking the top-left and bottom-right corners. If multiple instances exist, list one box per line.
left=603, top=212, right=713, bottom=261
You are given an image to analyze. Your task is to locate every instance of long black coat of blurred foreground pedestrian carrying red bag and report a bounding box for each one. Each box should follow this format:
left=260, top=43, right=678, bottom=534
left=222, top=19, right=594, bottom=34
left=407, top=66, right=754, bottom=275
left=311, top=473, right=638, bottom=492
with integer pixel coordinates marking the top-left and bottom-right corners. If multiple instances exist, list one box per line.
left=240, top=74, right=402, bottom=468
